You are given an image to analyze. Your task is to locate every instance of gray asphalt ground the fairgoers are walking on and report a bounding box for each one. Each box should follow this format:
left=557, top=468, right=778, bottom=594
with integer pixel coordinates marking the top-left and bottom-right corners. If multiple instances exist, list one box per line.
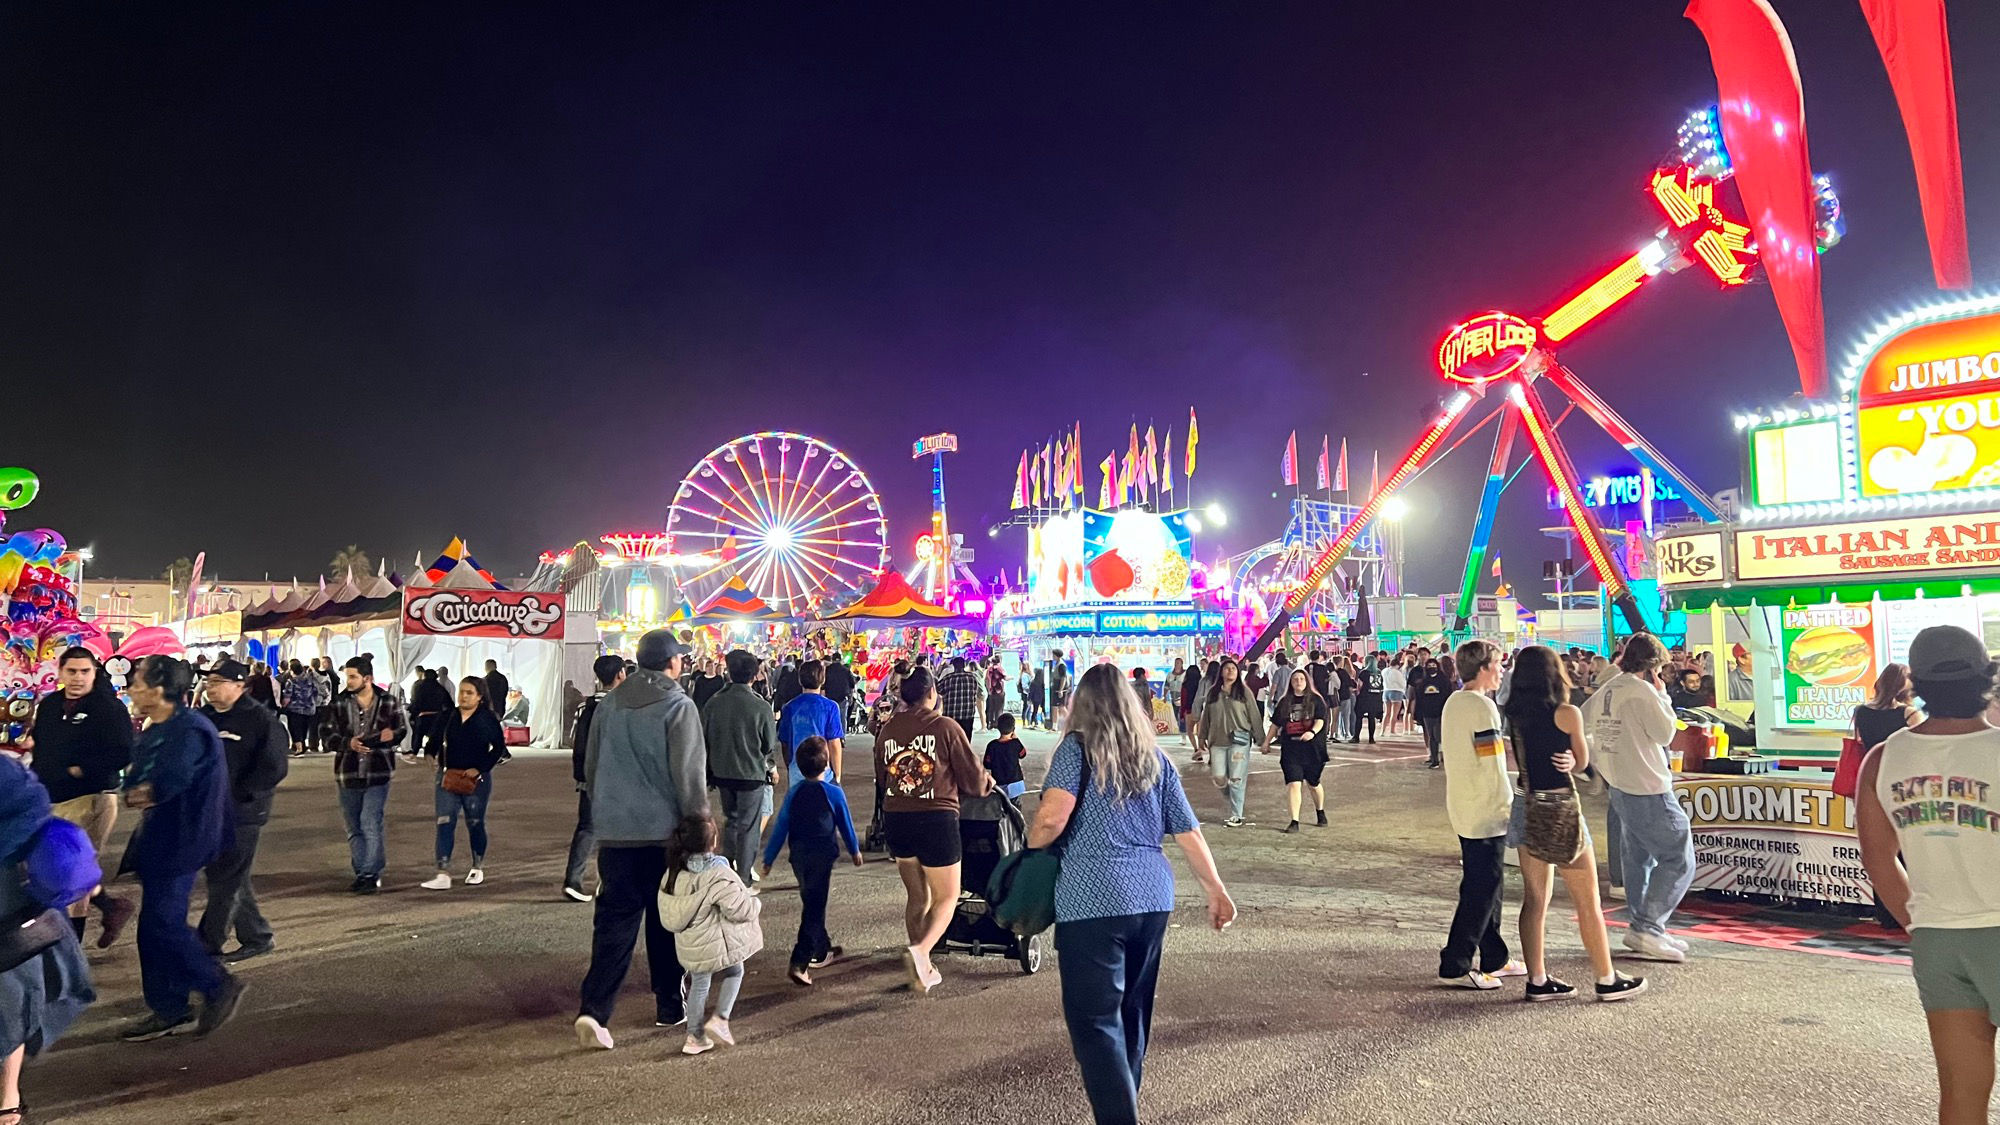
left=24, top=720, right=1934, bottom=1125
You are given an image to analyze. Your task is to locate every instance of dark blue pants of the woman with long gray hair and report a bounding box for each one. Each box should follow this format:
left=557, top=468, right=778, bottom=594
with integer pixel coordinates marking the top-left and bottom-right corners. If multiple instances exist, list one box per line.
left=1056, top=911, right=1170, bottom=1125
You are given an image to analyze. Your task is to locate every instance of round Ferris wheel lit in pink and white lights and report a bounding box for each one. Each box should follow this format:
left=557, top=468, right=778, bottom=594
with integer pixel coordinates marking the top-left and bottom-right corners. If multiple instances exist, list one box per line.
left=666, top=432, right=890, bottom=617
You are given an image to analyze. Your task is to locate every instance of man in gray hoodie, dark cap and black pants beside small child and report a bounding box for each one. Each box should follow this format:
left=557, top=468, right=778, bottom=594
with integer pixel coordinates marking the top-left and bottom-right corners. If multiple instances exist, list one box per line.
left=576, top=629, right=708, bottom=1049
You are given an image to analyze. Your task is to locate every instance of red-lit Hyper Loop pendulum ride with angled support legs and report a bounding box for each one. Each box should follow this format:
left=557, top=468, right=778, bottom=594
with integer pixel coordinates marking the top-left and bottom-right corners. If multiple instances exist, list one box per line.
left=1250, top=106, right=1844, bottom=657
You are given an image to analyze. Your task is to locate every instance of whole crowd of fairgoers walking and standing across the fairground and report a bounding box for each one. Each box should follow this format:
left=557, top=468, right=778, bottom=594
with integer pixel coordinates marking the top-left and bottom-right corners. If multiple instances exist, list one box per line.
left=15, top=612, right=2000, bottom=1125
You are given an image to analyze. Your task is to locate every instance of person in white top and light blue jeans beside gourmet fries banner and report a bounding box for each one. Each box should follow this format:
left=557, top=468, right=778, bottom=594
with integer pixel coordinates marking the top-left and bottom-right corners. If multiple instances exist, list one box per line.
left=1584, top=633, right=1694, bottom=961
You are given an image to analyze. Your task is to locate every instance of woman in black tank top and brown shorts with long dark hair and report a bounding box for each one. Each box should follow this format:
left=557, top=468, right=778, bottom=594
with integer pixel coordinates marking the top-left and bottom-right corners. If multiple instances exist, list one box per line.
left=1506, top=645, right=1646, bottom=1001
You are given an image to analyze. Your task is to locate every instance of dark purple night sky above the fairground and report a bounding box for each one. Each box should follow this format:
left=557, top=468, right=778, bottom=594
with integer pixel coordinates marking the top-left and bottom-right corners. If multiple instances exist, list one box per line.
left=0, top=0, right=2000, bottom=593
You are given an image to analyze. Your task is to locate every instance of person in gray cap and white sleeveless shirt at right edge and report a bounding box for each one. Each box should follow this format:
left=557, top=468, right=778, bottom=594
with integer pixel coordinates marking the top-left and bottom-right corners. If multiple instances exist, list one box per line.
left=1856, top=625, right=2000, bottom=1125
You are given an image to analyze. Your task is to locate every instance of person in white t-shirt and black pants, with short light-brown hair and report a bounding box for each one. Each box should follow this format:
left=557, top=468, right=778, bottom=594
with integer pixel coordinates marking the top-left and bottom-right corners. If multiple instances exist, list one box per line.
left=1438, top=641, right=1528, bottom=991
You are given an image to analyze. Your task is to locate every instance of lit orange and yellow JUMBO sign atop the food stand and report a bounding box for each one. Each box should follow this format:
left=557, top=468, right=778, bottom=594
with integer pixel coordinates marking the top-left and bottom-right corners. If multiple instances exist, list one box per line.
left=1856, top=312, right=2000, bottom=496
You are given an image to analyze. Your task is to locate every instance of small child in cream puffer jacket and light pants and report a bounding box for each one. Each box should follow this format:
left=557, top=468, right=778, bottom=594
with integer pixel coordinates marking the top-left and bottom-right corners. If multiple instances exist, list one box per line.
left=660, top=808, right=764, bottom=1055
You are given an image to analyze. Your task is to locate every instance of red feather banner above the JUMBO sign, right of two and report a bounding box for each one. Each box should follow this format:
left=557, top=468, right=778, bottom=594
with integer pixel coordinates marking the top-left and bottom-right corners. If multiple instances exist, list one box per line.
left=1862, top=0, right=1972, bottom=288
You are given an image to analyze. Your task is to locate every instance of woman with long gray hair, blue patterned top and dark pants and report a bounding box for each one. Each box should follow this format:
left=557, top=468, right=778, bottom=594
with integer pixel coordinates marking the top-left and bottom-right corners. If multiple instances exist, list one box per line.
left=1028, top=665, right=1236, bottom=1123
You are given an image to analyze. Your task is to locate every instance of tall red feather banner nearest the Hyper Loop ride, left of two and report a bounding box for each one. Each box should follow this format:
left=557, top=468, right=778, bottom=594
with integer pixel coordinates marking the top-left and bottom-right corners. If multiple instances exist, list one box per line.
left=1686, top=0, right=1826, bottom=398
